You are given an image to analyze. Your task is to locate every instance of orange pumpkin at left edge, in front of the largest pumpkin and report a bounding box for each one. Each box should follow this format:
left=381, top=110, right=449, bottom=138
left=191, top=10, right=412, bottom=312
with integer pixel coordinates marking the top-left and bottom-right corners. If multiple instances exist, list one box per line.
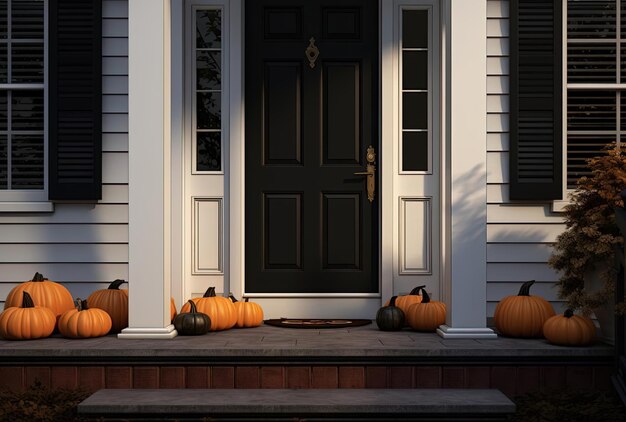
left=0, top=292, right=57, bottom=340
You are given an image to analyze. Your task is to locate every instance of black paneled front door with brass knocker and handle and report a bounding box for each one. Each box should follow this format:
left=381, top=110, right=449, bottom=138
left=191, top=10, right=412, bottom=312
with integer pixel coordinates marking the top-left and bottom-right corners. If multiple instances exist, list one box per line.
left=245, top=0, right=380, bottom=293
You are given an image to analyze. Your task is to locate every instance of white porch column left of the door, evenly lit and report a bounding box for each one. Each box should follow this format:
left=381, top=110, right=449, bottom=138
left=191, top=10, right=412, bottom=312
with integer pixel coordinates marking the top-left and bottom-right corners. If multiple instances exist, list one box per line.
left=118, top=0, right=177, bottom=339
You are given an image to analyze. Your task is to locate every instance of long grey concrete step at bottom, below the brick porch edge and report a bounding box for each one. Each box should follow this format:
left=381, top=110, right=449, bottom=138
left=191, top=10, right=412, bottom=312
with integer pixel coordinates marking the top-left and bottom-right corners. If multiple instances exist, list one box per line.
left=78, top=388, right=515, bottom=421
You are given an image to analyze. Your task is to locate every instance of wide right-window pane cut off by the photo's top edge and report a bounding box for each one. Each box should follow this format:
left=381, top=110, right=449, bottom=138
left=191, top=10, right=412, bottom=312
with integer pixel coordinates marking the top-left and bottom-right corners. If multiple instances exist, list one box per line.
left=567, top=0, right=617, bottom=38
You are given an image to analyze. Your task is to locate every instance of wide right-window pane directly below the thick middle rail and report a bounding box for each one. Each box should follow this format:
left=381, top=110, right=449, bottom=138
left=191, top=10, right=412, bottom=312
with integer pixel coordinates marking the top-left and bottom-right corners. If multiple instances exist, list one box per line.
left=567, top=90, right=617, bottom=131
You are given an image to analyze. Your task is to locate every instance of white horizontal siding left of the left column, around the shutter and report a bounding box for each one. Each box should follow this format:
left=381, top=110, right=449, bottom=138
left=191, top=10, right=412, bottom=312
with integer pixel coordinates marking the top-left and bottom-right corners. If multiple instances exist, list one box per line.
left=0, top=0, right=128, bottom=303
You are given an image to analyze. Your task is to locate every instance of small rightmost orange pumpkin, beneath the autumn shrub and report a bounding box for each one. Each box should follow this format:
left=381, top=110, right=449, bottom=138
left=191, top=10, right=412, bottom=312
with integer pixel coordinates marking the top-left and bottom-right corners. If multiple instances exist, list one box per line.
left=543, top=309, right=596, bottom=346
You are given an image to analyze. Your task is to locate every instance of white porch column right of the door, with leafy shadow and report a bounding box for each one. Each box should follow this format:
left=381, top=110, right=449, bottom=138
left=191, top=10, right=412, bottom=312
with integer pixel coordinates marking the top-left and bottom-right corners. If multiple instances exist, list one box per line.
left=437, top=0, right=497, bottom=338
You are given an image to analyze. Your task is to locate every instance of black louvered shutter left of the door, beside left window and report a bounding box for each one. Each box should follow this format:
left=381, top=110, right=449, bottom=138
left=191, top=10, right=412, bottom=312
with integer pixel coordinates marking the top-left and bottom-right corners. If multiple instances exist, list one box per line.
left=48, top=0, right=102, bottom=200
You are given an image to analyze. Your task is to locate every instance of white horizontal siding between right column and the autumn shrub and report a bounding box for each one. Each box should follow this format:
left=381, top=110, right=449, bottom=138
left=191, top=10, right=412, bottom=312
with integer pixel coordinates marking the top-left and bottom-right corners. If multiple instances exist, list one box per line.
left=486, top=0, right=565, bottom=316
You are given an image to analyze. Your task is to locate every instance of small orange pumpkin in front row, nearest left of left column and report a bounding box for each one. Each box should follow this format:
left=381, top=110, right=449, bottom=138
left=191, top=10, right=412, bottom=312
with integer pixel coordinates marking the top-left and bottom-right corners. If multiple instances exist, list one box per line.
left=59, top=298, right=112, bottom=338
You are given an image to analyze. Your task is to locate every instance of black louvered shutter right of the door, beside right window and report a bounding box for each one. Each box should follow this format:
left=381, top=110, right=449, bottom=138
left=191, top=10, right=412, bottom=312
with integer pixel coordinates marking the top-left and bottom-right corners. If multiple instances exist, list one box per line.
left=509, top=0, right=563, bottom=200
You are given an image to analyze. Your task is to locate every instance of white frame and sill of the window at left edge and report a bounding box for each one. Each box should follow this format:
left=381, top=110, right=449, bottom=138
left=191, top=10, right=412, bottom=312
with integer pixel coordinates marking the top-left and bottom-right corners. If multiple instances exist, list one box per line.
left=0, top=0, right=54, bottom=213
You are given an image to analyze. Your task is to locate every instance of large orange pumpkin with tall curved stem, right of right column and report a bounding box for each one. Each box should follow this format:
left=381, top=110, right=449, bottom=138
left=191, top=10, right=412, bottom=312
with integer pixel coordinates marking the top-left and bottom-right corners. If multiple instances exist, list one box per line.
left=493, top=280, right=554, bottom=337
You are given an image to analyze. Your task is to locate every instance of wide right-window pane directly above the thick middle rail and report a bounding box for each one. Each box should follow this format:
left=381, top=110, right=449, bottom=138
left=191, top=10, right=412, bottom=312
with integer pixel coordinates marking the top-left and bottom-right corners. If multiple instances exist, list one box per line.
left=567, top=43, right=617, bottom=83
